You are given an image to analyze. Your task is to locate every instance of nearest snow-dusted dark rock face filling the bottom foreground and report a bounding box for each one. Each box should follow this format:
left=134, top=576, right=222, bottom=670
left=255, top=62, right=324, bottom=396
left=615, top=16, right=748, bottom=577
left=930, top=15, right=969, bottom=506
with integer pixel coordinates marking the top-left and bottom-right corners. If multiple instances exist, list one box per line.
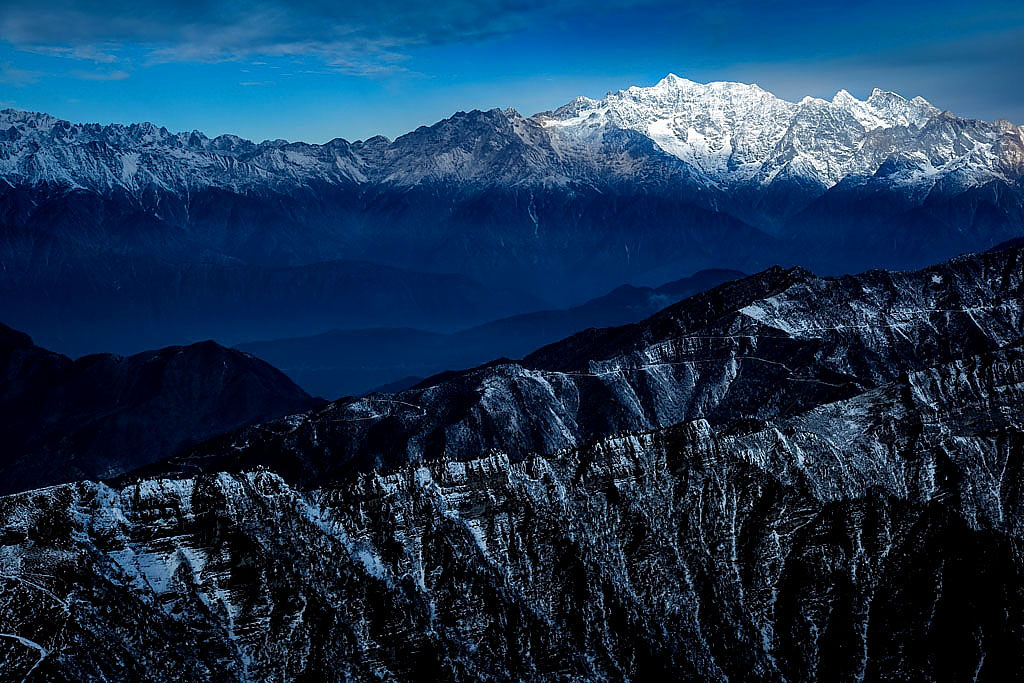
left=0, top=349, right=1024, bottom=681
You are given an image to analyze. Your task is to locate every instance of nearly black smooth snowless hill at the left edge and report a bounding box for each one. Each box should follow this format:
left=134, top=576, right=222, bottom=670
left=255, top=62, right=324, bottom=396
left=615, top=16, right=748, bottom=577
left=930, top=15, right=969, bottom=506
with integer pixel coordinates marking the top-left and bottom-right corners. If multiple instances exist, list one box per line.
left=0, top=325, right=317, bottom=494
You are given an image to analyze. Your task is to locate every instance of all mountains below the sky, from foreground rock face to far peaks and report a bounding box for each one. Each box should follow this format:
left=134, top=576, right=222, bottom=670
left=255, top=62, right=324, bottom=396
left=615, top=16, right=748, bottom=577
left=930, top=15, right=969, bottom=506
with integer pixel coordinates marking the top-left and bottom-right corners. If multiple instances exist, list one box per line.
left=0, top=75, right=1024, bottom=682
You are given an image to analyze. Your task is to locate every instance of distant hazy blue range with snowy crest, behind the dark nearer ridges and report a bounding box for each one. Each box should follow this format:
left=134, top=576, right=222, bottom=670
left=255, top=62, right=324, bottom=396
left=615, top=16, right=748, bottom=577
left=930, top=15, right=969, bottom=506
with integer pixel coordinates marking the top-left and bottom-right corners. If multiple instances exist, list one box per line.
left=0, top=75, right=1024, bottom=352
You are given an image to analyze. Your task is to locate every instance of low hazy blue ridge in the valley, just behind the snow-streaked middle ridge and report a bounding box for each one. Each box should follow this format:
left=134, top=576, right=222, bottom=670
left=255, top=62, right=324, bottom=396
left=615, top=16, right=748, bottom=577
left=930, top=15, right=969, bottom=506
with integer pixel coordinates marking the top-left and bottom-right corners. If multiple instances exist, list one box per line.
left=237, top=270, right=743, bottom=397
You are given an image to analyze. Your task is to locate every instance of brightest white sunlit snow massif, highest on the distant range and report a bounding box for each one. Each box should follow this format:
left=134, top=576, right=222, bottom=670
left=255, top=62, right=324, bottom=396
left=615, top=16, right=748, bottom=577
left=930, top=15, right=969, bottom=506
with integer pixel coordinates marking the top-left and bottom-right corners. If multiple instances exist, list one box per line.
left=541, top=74, right=998, bottom=188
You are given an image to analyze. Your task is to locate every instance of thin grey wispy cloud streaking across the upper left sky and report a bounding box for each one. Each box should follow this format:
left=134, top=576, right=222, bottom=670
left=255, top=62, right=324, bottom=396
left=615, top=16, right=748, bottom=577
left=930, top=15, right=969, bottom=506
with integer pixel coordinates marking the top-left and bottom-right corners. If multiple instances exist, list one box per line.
left=0, top=0, right=651, bottom=75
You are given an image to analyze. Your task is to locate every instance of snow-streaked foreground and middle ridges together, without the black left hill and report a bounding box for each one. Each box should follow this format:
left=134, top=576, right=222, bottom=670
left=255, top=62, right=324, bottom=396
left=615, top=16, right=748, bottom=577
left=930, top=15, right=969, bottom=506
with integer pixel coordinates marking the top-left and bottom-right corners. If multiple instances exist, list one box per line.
left=0, top=247, right=1024, bottom=681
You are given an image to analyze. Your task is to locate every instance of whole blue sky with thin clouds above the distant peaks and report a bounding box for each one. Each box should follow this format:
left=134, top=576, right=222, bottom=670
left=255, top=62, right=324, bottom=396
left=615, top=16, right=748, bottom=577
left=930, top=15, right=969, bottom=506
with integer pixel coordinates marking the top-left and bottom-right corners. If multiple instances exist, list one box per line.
left=0, top=0, right=1024, bottom=142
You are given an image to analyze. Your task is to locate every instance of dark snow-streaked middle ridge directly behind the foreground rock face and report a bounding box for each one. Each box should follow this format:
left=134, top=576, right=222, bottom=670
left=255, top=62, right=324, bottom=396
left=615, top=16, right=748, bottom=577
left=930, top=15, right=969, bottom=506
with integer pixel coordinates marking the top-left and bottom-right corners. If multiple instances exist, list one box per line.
left=157, top=242, right=1024, bottom=485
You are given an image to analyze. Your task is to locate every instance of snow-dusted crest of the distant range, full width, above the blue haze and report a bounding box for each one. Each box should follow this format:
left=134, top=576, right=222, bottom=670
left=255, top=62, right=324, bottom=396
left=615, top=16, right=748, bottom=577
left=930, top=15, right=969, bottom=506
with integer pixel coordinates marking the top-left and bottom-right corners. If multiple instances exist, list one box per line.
left=6, top=74, right=1024, bottom=191
